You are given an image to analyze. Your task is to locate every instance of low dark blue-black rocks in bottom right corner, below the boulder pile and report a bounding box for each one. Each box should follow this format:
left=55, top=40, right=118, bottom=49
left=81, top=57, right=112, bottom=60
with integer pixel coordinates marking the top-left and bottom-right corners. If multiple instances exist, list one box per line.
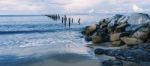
left=95, top=43, right=150, bottom=66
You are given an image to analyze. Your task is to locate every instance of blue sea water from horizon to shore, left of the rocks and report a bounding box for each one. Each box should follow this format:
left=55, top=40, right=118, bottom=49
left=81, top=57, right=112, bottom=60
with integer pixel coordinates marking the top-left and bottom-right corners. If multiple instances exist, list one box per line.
left=0, top=15, right=113, bottom=66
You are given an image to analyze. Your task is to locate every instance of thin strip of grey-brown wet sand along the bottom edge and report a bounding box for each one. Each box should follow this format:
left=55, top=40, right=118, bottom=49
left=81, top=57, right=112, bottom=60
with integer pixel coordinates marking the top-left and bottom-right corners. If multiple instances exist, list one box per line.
left=24, top=59, right=100, bottom=66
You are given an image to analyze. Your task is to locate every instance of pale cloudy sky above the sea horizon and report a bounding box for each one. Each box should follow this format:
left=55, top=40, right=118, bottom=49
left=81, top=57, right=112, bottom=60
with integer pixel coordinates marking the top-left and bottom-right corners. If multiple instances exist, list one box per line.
left=0, top=0, right=150, bottom=14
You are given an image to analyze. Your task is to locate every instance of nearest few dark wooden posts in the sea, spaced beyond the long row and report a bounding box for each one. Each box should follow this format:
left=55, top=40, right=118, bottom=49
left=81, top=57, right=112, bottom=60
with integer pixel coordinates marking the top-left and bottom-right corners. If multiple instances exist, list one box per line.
left=61, top=15, right=81, bottom=28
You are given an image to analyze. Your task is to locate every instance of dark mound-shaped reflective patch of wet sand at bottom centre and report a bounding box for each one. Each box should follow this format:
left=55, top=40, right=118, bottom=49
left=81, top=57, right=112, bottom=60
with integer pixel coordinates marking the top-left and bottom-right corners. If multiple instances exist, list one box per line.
left=25, top=53, right=100, bottom=66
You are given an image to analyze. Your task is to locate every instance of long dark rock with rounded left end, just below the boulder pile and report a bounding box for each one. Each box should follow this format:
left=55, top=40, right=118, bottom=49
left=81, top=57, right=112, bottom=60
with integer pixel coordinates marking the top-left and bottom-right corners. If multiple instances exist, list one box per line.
left=95, top=48, right=150, bottom=62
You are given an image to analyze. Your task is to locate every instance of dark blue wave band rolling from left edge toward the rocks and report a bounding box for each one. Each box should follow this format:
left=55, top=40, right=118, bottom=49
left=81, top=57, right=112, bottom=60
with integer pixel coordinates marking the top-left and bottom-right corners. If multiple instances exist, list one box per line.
left=0, top=24, right=82, bottom=34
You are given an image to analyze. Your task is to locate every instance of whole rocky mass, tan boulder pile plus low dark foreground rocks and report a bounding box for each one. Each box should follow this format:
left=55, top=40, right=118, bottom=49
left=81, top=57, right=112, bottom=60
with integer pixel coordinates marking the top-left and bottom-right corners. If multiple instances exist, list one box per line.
left=82, top=13, right=150, bottom=66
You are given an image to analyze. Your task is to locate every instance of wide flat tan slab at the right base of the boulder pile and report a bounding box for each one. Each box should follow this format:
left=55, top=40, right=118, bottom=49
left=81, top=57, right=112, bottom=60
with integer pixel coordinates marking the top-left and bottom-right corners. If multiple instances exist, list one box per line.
left=121, top=37, right=143, bottom=45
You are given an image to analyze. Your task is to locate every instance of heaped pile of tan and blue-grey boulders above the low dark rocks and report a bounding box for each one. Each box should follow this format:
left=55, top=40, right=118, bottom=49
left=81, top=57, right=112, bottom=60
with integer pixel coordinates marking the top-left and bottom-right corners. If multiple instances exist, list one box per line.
left=82, top=13, right=150, bottom=46
